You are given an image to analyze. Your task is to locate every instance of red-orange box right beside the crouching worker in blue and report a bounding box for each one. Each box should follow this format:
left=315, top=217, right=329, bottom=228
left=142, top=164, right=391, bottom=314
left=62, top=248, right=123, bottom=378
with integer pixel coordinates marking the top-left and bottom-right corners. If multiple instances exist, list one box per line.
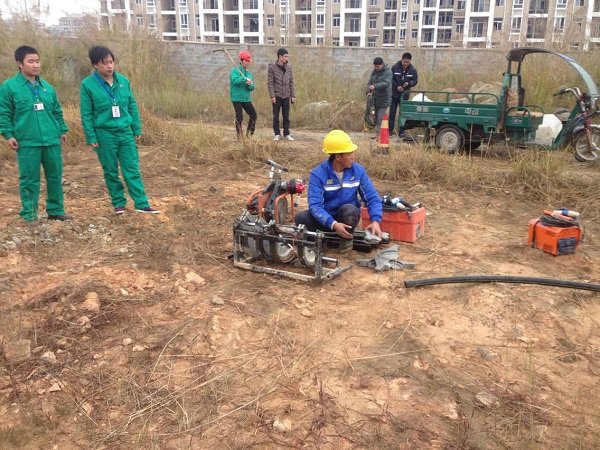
left=360, top=207, right=426, bottom=242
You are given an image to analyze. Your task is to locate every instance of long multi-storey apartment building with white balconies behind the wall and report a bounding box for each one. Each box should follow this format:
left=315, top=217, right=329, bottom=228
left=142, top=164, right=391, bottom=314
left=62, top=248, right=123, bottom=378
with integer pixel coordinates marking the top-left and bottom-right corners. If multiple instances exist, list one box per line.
left=100, top=0, right=600, bottom=50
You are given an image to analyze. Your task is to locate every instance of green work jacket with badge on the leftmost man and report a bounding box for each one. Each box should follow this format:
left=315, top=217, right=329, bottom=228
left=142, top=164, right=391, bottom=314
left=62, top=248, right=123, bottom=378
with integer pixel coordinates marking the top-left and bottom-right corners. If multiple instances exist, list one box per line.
left=0, top=72, right=69, bottom=147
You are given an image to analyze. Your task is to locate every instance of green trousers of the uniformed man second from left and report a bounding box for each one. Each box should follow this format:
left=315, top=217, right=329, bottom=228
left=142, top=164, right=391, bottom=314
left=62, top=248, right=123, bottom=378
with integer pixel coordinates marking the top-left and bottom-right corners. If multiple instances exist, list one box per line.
left=96, top=129, right=150, bottom=209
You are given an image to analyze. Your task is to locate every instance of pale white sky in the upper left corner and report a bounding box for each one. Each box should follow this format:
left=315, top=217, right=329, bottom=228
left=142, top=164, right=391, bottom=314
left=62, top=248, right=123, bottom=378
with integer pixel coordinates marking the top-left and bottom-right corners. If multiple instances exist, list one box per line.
left=0, top=0, right=100, bottom=25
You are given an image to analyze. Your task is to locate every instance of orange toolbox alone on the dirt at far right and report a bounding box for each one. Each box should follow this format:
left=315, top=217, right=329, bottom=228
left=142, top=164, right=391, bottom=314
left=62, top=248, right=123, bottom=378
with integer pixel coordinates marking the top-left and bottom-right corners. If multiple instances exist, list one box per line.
left=528, top=219, right=581, bottom=256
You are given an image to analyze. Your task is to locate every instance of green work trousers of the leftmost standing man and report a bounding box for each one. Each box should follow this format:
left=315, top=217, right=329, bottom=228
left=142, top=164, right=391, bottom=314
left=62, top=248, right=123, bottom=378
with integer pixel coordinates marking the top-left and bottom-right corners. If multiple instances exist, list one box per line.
left=17, top=145, right=65, bottom=221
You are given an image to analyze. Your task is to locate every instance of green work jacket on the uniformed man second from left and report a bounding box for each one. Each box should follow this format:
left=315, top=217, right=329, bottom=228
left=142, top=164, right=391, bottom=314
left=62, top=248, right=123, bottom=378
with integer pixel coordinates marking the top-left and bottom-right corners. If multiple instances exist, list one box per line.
left=79, top=71, right=142, bottom=144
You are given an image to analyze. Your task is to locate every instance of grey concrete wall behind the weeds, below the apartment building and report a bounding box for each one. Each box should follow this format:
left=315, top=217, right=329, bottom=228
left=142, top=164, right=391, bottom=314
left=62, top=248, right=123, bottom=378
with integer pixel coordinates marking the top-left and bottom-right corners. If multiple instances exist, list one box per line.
left=165, top=42, right=506, bottom=89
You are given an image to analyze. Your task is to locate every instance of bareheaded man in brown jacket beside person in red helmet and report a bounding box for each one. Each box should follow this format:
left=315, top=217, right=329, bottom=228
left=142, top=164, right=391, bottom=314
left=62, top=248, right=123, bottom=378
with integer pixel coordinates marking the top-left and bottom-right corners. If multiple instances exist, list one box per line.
left=267, top=48, right=296, bottom=141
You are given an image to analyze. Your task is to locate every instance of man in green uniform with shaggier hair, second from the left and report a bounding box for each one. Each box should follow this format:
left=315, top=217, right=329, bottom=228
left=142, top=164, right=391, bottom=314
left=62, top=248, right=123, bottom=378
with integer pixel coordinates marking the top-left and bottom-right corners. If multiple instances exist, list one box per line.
left=80, top=46, right=160, bottom=214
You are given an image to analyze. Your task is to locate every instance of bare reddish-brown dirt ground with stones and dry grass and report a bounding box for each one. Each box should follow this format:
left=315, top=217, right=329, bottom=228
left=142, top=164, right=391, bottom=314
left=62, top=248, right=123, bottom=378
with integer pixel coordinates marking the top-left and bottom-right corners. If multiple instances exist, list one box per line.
left=0, top=127, right=600, bottom=450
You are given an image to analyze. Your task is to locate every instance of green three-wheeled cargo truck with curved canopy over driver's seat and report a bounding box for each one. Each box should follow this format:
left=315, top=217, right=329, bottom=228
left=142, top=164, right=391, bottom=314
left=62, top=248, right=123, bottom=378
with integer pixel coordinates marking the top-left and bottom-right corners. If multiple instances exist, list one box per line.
left=398, top=47, right=600, bottom=161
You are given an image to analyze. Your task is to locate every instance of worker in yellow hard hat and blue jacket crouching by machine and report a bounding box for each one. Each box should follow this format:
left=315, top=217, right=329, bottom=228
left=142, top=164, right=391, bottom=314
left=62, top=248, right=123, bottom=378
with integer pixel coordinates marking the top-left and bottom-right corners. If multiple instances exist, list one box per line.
left=296, top=130, right=383, bottom=252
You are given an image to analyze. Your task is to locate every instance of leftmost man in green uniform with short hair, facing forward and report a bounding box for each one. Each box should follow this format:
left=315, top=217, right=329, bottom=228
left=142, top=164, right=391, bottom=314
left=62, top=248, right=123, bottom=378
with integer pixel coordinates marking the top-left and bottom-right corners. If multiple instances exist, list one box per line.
left=0, top=45, right=71, bottom=222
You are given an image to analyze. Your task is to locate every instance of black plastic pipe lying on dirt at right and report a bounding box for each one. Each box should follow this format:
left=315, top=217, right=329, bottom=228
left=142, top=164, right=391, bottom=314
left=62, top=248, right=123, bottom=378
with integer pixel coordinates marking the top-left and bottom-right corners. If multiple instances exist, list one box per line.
left=404, top=275, right=600, bottom=292
